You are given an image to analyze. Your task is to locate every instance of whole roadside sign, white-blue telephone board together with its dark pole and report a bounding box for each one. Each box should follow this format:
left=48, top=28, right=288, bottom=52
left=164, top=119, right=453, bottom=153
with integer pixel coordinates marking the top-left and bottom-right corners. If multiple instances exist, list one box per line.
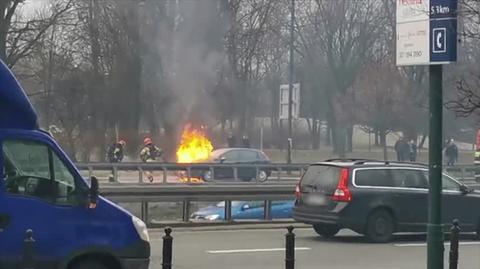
left=396, top=0, right=458, bottom=269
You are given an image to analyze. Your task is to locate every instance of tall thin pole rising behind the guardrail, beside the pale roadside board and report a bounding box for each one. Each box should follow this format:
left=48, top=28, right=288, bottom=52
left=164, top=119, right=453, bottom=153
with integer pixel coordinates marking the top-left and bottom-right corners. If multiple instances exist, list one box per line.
left=287, top=0, right=295, bottom=163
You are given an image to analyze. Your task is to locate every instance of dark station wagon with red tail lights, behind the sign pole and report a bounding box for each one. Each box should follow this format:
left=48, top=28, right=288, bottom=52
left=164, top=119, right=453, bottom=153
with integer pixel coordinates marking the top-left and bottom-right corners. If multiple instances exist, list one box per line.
left=293, top=160, right=480, bottom=242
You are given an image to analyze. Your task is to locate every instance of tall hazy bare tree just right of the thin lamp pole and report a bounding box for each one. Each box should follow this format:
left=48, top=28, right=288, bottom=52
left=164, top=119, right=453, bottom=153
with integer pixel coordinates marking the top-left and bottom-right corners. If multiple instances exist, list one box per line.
left=298, top=0, right=384, bottom=157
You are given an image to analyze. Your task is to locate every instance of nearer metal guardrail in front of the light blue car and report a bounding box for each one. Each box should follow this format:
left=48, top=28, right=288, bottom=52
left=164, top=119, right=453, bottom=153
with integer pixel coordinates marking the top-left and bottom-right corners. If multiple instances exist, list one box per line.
left=100, top=184, right=295, bottom=225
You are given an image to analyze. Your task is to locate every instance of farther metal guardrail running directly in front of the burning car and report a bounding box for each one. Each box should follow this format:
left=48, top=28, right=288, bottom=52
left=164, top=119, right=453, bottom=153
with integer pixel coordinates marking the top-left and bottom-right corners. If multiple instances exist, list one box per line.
left=76, top=160, right=308, bottom=183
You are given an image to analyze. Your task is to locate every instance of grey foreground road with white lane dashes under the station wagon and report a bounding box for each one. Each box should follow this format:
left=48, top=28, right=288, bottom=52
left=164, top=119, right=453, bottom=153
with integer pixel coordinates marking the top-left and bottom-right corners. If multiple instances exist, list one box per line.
left=150, top=228, right=480, bottom=269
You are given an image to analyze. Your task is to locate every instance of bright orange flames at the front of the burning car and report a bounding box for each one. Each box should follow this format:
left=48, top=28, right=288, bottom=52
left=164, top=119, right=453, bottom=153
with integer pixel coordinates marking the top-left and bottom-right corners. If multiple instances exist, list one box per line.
left=177, top=126, right=213, bottom=163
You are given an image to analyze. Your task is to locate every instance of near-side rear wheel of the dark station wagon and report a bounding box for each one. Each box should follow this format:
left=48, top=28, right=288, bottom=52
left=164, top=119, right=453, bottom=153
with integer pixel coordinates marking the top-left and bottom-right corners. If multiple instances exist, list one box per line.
left=365, top=210, right=395, bottom=243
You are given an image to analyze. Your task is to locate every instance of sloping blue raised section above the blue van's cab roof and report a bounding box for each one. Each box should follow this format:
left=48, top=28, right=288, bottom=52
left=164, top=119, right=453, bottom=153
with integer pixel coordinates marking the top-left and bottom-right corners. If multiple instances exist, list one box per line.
left=0, top=61, right=38, bottom=130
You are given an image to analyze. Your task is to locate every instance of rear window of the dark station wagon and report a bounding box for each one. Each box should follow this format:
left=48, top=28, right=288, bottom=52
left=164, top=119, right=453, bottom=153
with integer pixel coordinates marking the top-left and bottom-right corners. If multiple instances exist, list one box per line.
left=301, top=165, right=341, bottom=193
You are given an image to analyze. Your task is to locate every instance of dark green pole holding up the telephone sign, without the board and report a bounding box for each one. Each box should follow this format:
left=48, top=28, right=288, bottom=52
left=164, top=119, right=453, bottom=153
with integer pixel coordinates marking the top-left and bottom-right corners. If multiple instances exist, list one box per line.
left=427, top=65, right=444, bottom=269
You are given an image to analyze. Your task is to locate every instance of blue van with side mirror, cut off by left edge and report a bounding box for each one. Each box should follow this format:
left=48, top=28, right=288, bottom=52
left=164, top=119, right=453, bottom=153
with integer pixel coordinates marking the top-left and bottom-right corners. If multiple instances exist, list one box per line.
left=0, top=59, right=150, bottom=269
